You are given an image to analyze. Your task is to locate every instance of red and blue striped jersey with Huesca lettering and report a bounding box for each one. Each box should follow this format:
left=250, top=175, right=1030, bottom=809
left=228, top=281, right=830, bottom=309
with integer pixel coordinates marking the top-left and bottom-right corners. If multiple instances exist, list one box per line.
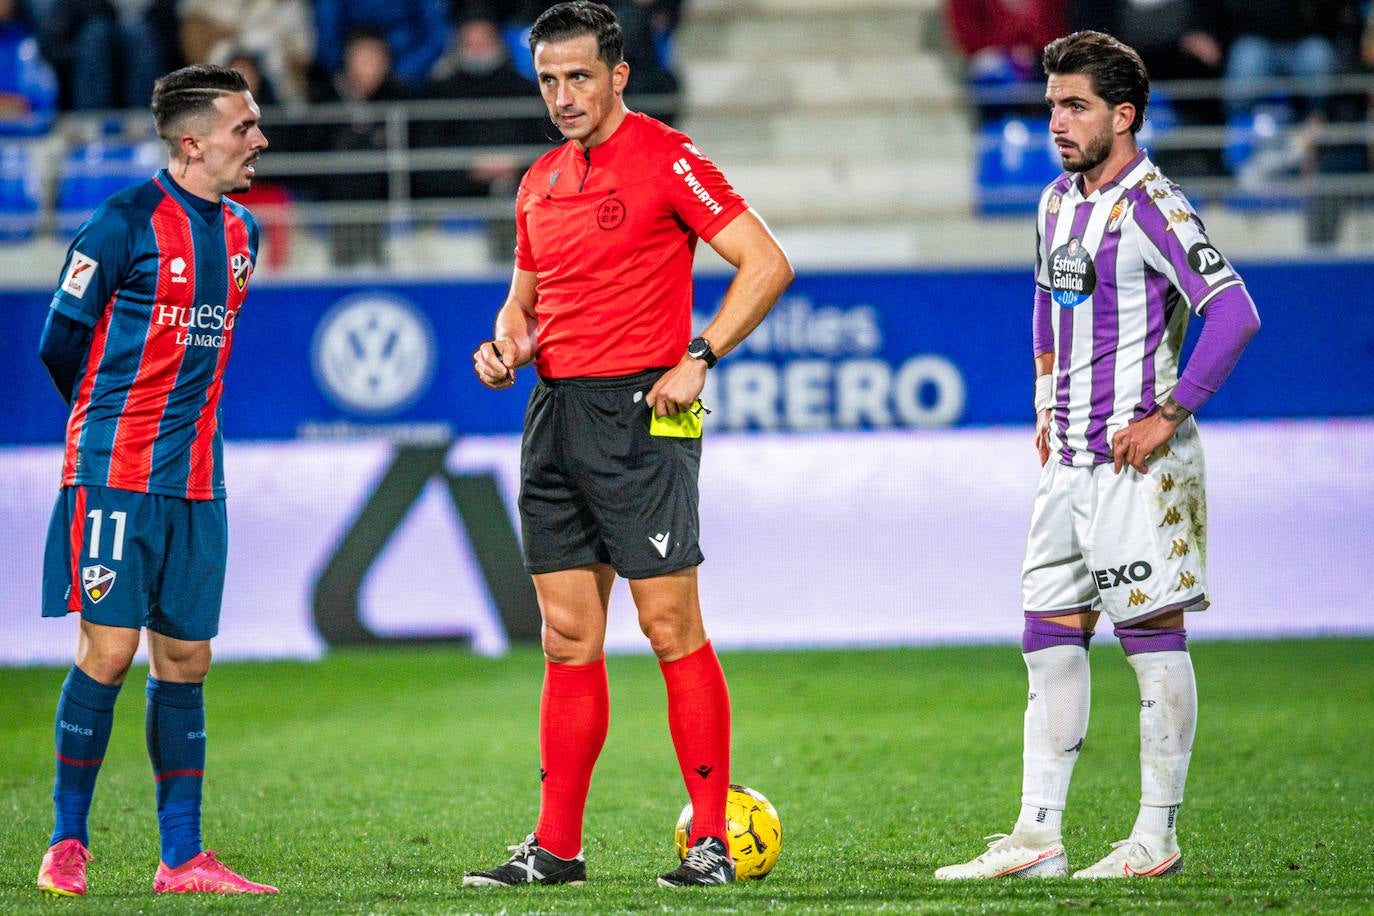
left=52, top=169, right=258, bottom=500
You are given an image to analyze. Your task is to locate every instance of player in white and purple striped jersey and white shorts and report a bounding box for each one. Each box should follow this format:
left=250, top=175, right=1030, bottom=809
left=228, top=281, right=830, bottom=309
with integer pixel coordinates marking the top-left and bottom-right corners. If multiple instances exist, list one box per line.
left=936, top=32, right=1259, bottom=879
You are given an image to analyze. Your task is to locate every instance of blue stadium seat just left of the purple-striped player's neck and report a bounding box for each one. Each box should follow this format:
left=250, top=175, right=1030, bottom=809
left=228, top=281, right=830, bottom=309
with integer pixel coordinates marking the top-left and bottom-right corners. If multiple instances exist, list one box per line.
left=977, top=118, right=1062, bottom=216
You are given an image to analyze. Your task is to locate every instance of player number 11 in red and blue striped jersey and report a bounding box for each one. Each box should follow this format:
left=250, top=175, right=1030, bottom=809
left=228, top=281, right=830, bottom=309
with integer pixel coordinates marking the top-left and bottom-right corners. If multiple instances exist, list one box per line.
left=38, top=66, right=276, bottom=897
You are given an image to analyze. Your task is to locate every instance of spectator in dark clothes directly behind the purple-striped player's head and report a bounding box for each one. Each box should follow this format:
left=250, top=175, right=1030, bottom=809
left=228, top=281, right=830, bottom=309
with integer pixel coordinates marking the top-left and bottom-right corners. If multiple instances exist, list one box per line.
left=1069, top=0, right=1226, bottom=177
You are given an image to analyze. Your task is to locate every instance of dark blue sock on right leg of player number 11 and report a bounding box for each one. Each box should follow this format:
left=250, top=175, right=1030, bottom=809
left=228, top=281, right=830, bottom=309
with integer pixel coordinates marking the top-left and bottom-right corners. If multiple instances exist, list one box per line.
left=146, top=676, right=205, bottom=868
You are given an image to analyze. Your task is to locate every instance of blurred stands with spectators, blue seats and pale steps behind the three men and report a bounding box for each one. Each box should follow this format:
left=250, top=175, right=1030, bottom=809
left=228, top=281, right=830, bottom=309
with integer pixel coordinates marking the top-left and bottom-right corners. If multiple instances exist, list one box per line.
left=0, top=0, right=1374, bottom=271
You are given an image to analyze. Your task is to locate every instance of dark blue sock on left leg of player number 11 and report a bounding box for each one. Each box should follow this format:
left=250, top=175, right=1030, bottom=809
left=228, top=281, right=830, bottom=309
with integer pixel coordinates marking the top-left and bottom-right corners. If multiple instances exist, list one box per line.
left=48, top=665, right=120, bottom=846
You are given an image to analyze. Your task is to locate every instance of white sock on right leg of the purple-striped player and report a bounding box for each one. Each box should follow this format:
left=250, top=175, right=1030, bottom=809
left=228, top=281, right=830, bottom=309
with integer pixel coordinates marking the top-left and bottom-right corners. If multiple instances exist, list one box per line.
left=1127, top=651, right=1198, bottom=836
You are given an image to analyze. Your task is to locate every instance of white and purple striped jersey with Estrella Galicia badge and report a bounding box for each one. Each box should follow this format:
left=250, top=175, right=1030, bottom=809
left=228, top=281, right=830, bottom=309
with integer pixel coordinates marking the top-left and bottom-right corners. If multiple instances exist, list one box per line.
left=1035, top=150, right=1242, bottom=467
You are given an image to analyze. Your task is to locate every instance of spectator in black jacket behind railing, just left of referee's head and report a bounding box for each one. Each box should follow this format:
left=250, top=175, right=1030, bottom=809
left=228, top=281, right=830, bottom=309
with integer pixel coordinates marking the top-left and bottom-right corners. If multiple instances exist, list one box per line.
left=411, top=18, right=552, bottom=258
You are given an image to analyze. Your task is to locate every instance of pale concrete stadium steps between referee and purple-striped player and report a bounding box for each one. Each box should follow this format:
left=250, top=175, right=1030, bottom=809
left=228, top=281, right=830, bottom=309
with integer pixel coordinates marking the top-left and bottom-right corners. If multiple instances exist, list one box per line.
left=676, top=0, right=1031, bottom=268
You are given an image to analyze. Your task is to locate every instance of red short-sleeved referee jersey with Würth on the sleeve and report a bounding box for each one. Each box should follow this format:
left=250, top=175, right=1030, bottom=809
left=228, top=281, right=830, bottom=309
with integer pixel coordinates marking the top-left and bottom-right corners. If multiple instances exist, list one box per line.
left=515, top=111, right=747, bottom=379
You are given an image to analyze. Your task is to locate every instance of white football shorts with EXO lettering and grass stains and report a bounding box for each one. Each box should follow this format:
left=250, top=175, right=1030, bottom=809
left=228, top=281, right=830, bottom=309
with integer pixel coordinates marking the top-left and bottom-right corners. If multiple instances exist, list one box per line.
left=1021, top=417, right=1208, bottom=625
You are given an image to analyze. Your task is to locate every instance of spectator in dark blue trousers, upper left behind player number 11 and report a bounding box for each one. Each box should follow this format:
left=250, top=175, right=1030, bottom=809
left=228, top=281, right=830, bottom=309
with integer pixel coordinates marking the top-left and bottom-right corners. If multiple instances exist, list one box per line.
left=32, top=0, right=180, bottom=111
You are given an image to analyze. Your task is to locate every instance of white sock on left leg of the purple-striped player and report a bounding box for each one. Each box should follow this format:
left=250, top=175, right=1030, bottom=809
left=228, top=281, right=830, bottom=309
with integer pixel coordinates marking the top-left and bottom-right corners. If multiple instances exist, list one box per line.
left=1015, top=645, right=1092, bottom=836
